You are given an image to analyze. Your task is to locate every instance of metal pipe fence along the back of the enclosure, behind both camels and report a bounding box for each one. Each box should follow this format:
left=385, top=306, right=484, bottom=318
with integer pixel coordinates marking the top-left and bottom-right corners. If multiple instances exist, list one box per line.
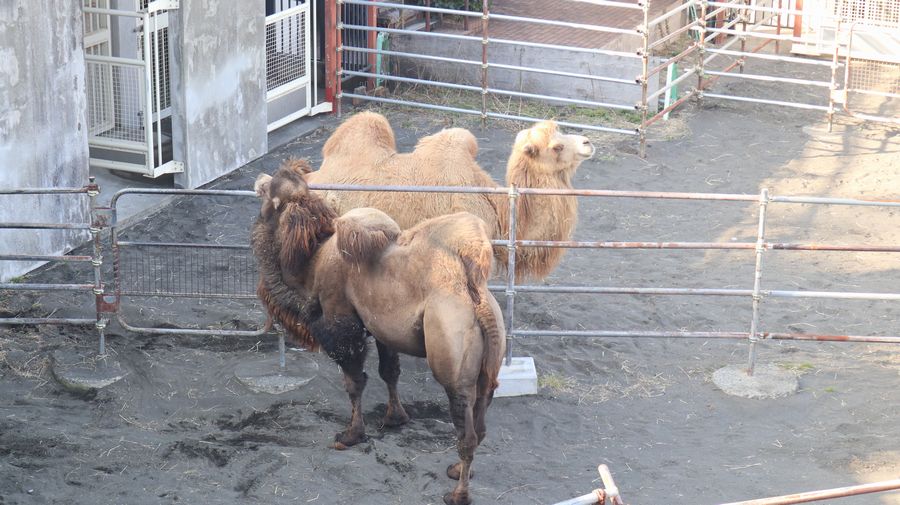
left=336, top=0, right=900, bottom=156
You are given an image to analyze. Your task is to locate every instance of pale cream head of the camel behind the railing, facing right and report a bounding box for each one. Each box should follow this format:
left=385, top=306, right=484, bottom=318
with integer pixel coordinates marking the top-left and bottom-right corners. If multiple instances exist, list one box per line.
left=507, top=121, right=594, bottom=185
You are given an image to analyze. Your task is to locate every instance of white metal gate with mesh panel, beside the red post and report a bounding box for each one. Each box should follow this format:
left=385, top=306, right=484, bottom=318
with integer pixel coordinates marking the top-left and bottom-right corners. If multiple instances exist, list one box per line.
left=266, top=0, right=331, bottom=131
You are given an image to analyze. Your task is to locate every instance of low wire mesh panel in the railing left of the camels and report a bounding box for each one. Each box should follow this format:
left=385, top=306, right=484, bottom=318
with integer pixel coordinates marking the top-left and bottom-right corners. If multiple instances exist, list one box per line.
left=118, top=242, right=258, bottom=299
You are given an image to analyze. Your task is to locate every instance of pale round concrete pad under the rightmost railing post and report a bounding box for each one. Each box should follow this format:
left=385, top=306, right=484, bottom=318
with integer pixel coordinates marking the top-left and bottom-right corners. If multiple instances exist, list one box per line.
left=713, top=364, right=800, bottom=398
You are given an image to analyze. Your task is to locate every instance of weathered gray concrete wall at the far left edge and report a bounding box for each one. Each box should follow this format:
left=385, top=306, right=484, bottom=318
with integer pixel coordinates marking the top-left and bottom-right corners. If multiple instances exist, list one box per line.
left=0, top=0, right=88, bottom=280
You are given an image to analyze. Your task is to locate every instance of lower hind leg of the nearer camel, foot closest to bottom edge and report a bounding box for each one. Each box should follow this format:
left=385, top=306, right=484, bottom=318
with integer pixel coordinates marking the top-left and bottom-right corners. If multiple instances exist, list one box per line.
left=444, top=388, right=478, bottom=505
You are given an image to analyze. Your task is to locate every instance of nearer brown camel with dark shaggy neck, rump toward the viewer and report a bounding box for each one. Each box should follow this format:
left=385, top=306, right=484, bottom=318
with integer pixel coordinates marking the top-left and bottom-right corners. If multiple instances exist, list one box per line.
left=251, top=160, right=506, bottom=505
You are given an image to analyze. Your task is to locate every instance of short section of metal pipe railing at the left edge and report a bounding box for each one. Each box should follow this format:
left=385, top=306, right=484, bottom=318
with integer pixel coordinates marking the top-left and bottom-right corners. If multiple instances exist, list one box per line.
left=0, top=177, right=107, bottom=355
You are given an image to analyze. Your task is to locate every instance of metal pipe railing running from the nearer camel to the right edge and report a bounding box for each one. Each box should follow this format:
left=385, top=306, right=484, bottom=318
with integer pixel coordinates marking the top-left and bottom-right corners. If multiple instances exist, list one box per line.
left=310, top=180, right=900, bottom=374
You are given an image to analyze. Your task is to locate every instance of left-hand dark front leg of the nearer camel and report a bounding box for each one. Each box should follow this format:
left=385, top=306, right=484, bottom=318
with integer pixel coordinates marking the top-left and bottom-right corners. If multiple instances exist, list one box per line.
left=312, top=319, right=368, bottom=450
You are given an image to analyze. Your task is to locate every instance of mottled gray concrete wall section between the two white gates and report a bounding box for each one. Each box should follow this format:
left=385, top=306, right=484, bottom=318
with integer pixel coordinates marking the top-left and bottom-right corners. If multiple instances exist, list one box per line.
left=169, top=0, right=267, bottom=188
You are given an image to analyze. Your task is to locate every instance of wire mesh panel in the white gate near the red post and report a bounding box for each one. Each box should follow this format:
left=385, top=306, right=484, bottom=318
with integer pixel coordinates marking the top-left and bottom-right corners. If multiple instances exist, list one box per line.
left=266, top=6, right=309, bottom=92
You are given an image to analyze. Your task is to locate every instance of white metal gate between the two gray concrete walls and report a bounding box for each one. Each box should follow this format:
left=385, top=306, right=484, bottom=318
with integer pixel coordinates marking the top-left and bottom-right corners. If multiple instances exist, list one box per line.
left=83, top=0, right=184, bottom=177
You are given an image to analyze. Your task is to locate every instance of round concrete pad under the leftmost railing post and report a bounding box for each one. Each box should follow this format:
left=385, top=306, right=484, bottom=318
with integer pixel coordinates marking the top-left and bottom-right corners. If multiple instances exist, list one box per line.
left=50, top=349, right=128, bottom=392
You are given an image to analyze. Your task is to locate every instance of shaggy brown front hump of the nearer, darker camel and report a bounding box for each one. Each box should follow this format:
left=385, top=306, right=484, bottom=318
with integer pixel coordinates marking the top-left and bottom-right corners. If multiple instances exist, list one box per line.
left=334, top=207, right=400, bottom=263
